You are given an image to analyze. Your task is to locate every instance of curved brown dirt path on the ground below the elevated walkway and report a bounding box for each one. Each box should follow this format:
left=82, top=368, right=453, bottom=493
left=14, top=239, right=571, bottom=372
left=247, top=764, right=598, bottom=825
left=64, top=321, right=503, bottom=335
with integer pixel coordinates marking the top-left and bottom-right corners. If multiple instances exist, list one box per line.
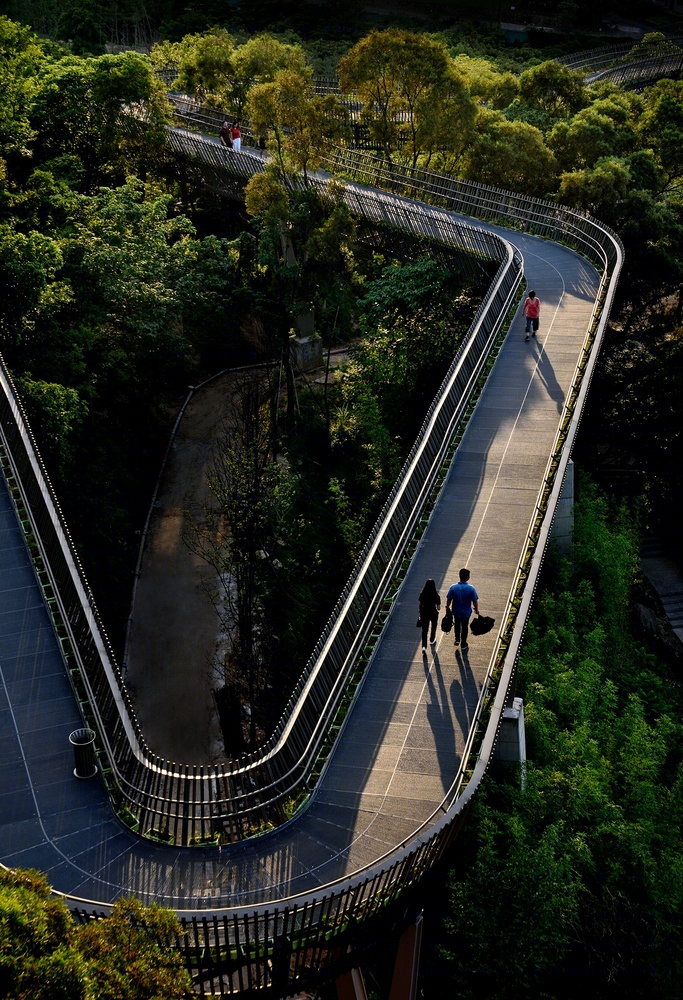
left=126, top=374, right=240, bottom=764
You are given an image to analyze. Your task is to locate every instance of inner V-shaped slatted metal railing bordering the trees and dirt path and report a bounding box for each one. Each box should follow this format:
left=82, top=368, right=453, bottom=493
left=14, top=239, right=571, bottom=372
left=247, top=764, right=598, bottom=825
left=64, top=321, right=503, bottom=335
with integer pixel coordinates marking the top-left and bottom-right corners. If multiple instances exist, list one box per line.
left=2, top=125, right=521, bottom=844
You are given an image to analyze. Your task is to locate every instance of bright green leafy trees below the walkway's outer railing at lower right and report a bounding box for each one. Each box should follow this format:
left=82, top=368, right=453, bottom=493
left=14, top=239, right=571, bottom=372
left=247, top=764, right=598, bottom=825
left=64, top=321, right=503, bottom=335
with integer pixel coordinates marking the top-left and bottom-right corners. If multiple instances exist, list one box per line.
left=424, top=484, right=683, bottom=998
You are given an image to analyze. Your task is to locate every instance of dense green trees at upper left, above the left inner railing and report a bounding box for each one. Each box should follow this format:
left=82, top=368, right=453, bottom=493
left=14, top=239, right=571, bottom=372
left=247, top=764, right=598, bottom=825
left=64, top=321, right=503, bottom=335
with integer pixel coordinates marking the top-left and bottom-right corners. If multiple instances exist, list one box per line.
left=0, top=18, right=251, bottom=638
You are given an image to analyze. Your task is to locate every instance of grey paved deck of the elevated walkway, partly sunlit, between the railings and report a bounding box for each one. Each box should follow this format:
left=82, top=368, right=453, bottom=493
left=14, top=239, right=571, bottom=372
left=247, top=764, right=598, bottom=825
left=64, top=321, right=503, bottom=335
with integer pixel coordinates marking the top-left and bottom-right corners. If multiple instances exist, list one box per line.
left=0, top=207, right=598, bottom=912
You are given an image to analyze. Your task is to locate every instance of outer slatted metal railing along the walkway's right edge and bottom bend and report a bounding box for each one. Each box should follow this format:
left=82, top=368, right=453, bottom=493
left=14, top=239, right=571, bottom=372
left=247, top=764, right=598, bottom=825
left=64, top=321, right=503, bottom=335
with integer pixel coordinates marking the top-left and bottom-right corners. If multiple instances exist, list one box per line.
left=97, top=125, right=623, bottom=996
